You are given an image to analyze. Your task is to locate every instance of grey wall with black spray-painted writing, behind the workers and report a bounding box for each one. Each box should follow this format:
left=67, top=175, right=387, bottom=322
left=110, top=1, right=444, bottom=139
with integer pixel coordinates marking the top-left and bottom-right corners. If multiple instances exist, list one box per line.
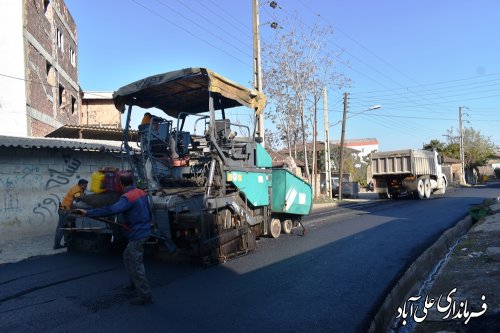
left=0, top=147, right=121, bottom=244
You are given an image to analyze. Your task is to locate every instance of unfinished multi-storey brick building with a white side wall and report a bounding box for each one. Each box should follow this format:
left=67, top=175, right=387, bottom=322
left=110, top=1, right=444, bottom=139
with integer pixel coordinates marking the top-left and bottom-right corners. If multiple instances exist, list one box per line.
left=0, top=0, right=81, bottom=136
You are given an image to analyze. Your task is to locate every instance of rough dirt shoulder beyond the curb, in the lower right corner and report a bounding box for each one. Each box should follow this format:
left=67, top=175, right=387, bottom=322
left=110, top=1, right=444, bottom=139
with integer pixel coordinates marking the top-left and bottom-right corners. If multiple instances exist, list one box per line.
left=406, top=201, right=500, bottom=333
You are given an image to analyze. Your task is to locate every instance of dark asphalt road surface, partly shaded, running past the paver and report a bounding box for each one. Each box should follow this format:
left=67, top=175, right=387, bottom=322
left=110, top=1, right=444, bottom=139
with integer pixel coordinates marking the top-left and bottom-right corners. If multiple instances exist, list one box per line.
left=0, top=185, right=500, bottom=333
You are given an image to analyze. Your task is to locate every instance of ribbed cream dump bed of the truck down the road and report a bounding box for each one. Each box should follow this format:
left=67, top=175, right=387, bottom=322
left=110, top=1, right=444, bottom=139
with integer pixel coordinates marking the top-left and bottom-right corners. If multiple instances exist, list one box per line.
left=371, top=149, right=437, bottom=176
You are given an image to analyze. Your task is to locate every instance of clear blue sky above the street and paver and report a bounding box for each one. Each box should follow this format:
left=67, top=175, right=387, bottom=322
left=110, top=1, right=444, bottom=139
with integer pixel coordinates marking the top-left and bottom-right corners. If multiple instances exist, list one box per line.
left=65, top=0, right=500, bottom=150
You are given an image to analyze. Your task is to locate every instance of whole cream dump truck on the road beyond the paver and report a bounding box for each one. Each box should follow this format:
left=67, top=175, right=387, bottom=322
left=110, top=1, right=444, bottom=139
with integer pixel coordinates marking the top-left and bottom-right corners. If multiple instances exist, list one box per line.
left=371, top=149, right=448, bottom=199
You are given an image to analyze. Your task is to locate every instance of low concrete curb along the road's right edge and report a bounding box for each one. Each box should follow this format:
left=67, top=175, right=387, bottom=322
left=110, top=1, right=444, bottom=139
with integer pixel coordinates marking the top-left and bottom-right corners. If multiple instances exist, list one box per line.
left=368, top=216, right=472, bottom=333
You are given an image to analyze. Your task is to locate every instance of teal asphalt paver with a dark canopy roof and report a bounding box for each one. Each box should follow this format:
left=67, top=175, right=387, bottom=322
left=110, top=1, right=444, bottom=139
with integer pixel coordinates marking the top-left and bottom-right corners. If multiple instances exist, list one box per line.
left=66, top=68, right=312, bottom=264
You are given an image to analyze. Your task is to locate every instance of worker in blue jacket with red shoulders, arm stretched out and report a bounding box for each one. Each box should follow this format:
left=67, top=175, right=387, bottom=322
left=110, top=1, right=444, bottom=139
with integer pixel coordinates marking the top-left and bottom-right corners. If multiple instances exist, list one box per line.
left=74, top=172, right=153, bottom=305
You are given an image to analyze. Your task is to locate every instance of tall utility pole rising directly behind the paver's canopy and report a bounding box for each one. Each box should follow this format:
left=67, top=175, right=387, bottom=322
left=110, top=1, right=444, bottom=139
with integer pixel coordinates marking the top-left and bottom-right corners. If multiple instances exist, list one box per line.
left=252, top=0, right=264, bottom=146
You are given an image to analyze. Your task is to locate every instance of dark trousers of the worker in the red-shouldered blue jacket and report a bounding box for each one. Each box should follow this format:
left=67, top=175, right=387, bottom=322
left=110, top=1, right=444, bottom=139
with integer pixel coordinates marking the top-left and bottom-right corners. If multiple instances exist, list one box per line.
left=123, top=238, right=151, bottom=297
